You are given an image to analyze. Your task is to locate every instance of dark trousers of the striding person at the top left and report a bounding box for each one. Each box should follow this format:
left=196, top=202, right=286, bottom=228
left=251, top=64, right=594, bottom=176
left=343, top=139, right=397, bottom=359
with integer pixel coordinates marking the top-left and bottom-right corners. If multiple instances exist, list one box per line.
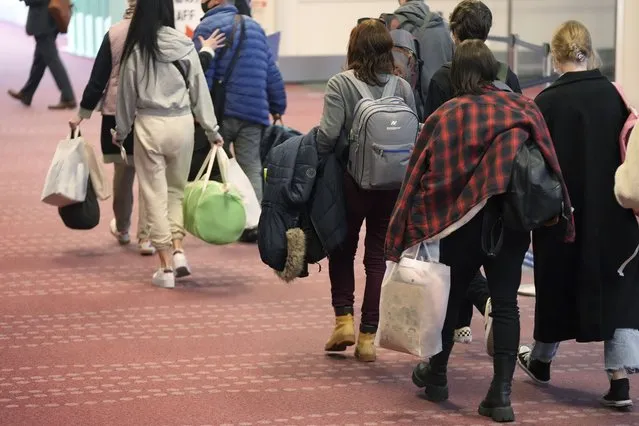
left=20, top=33, right=75, bottom=103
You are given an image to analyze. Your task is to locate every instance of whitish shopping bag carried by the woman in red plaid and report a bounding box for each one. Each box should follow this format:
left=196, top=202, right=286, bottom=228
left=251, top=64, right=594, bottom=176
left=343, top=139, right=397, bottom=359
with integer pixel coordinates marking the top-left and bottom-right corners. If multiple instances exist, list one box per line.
left=375, top=244, right=450, bottom=359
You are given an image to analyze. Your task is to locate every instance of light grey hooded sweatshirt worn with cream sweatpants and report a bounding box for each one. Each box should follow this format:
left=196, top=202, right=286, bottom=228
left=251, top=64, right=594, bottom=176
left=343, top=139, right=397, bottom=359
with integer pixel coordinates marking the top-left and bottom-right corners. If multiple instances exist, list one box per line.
left=115, top=27, right=217, bottom=141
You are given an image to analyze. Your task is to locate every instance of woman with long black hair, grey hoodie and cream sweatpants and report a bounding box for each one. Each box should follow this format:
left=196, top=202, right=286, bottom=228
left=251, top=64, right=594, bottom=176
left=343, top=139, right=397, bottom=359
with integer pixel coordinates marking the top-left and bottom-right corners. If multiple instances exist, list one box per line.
left=113, top=0, right=223, bottom=288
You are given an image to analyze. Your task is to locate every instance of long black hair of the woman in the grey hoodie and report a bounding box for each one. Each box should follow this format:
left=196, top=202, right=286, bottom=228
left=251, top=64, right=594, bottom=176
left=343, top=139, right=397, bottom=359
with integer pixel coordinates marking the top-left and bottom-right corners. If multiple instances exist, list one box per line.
left=121, top=0, right=175, bottom=65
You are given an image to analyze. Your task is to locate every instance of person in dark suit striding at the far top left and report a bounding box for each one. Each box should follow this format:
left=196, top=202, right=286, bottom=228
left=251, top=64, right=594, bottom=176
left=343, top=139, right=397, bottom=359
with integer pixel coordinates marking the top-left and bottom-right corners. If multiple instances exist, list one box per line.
left=5, top=0, right=77, bottom=110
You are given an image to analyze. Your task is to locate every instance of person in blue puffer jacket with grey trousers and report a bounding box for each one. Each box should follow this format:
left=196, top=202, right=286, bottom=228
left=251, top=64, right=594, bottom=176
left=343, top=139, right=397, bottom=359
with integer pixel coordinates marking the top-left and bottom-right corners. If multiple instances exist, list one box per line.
left=193, top=0, right=286, bottom=206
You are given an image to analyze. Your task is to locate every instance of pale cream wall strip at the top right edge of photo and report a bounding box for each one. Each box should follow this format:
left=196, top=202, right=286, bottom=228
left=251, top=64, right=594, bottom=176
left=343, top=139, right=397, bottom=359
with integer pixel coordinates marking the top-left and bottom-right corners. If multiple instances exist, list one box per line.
left=616, top=0, right=639, bottom=105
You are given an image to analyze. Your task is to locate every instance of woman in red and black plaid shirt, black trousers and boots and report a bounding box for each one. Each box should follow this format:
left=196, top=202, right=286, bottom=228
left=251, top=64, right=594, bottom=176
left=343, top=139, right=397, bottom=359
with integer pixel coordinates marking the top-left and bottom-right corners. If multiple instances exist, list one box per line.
left=386, top=40, right=574, bottom=422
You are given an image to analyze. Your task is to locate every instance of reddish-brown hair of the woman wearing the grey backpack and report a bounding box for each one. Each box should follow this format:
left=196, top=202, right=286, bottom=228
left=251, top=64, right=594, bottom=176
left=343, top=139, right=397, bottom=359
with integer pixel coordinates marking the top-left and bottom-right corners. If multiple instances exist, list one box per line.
left=347, top=19, right=395, bottom=86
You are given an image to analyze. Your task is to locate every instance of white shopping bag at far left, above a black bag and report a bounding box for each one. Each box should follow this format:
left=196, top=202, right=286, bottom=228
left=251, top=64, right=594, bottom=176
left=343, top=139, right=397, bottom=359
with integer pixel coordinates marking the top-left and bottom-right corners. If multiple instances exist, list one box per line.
left=41, top=129, right=89, bottom=207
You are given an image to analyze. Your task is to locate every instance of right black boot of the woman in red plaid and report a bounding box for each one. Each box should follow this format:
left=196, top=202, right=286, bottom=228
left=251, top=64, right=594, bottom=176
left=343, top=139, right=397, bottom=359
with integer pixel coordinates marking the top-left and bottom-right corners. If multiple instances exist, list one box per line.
left=478, top=355, right=517, bottom=423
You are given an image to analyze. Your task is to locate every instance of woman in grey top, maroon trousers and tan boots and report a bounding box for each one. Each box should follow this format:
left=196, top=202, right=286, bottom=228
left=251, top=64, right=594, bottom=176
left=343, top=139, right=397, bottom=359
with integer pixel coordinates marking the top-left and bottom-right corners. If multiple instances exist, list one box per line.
left=317, top=19, right=419, bottom=362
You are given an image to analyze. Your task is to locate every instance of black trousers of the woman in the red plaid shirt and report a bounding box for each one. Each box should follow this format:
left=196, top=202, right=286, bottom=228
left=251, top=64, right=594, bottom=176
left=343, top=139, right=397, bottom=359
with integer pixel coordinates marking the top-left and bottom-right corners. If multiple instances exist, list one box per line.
left=433, top=211, right=530, bottom=364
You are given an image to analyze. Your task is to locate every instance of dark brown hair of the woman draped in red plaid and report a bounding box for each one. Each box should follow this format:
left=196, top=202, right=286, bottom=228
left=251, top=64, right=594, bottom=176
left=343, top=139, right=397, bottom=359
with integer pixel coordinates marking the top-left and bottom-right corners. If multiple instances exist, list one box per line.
left=450, top=40, right=499, bottom=96
